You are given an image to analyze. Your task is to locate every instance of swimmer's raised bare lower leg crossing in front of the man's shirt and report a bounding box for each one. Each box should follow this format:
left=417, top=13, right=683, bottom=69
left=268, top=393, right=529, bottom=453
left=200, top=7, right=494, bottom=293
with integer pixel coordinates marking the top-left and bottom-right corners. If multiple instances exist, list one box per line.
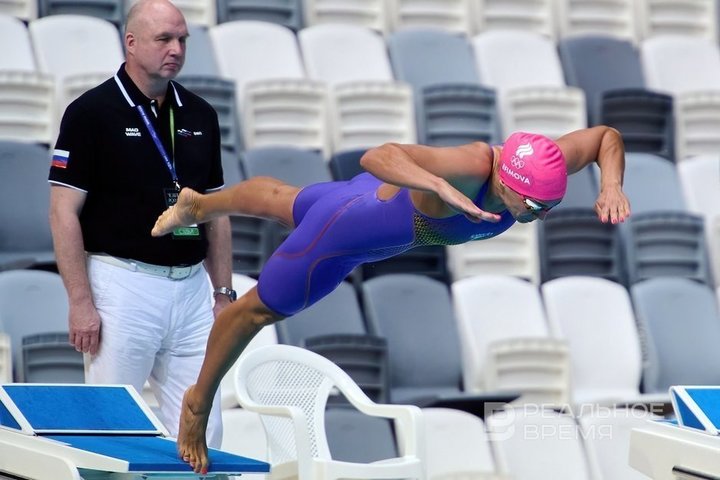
left=151, top=177, right=300, bottom=237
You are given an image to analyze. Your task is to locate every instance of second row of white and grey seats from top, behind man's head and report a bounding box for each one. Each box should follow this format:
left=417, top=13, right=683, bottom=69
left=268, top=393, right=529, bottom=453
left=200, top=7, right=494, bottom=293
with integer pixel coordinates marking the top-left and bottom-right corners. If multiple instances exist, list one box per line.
left=0, top=15, right=720, bottom=165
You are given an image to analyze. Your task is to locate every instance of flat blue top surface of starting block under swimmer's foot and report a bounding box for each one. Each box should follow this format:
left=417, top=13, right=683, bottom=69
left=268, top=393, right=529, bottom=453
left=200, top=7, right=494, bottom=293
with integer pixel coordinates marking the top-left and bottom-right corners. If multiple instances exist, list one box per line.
left=45, top=435, right=270, bottom=474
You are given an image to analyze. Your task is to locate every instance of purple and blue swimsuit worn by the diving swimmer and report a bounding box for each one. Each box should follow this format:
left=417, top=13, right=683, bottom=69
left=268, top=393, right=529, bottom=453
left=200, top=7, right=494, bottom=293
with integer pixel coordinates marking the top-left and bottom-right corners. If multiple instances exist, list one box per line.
left=258, top=173, right=515, bottom=316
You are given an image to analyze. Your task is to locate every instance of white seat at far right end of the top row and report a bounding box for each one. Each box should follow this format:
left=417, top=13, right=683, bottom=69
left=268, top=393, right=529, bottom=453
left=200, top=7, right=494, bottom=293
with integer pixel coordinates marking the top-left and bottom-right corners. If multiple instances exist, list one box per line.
left=636, top=0, right=717, bottom=42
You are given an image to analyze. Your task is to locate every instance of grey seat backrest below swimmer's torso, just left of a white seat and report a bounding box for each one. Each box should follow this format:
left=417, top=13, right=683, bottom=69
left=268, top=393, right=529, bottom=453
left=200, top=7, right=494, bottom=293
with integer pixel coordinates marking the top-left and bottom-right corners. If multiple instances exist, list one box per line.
left=362, top=274, right=462, bottom=403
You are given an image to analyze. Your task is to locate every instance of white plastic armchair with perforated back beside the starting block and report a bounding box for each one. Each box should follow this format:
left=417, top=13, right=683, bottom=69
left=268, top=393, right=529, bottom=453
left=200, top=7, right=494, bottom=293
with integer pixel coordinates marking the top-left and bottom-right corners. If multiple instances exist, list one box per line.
left=235, top=345, right=426, bottom=480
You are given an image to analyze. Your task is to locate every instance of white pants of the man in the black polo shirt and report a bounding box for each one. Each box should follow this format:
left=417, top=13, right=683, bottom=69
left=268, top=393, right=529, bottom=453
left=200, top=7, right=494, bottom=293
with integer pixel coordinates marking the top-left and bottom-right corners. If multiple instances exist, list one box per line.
left=85, top=257, right=222, bottom=448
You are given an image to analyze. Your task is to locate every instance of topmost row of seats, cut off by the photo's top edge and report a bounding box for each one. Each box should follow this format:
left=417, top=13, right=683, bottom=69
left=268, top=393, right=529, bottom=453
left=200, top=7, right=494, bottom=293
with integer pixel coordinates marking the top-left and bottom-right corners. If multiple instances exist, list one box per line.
left=0, top=0, right=717, bottom=41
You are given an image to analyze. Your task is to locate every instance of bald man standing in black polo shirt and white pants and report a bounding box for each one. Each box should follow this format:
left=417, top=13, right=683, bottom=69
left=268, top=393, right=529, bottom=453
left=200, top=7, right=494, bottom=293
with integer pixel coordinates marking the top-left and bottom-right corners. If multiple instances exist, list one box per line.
left=50, top=0, right=234, bottom=446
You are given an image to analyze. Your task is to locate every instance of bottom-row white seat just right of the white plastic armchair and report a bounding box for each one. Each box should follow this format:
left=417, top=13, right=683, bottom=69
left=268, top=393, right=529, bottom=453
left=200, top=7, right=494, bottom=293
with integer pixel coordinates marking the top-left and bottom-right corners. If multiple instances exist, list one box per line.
left=423, top=408, right=503, bottom=480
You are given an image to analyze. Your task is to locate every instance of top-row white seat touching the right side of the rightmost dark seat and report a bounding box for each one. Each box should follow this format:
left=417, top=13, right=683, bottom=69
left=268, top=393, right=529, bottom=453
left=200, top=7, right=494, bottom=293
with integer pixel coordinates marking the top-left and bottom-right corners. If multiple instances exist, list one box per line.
left=303, top=0, right=388, bottom=33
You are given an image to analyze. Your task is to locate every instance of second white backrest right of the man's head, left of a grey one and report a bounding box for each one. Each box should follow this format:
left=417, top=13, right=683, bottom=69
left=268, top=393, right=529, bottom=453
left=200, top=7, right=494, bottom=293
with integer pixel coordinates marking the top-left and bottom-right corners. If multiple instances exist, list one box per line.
left=298, top=24, right=393, bottom=85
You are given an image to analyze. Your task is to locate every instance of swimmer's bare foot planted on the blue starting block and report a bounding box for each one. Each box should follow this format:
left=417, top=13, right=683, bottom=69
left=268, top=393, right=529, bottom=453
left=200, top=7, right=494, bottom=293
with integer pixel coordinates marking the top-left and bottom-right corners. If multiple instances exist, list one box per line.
left=177, top=385, right=210, bottom=475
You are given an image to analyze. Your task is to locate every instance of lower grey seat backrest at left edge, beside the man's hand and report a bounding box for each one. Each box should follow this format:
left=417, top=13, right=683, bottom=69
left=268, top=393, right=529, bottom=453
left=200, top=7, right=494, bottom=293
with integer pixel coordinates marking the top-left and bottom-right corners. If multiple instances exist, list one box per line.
left=0, top=270, right=68, bottom=381
